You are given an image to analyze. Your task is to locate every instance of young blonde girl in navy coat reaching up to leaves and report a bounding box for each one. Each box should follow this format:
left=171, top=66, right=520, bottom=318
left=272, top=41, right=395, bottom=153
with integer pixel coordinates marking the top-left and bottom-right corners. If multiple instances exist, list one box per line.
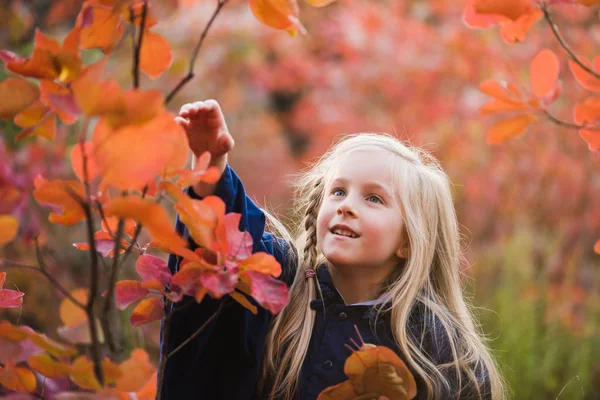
left=162, top=100, right=504, bottom=400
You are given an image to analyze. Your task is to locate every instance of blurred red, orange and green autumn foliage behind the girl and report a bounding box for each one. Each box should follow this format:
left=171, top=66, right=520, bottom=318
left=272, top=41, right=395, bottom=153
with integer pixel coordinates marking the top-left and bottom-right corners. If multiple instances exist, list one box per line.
left=0, top=0, right=600, bottom=399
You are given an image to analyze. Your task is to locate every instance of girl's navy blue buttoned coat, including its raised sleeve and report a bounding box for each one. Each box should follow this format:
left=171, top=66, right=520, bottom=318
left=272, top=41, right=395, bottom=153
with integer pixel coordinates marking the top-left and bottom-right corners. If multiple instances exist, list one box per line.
left=162, top=167, right=488, bottom=400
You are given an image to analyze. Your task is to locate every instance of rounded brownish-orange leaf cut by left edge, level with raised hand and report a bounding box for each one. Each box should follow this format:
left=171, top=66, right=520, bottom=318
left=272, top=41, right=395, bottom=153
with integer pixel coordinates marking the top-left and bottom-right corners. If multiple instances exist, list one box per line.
left=0, top=78, right=40, bottom=119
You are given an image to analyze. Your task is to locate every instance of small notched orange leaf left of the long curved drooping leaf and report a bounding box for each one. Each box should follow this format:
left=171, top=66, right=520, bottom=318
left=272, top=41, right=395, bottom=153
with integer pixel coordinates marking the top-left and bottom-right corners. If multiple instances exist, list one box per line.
left=33, top=176, right=85, bottom=225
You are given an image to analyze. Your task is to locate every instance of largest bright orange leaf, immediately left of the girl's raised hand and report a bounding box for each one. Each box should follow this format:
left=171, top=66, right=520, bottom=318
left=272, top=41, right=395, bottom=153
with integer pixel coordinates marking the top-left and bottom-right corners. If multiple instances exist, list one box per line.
left=92, top=111, right=189, bottom=190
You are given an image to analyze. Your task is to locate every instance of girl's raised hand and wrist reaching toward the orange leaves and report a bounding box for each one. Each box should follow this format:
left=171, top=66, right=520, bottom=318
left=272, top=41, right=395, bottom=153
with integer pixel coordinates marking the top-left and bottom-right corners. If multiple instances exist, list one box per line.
left=175, top=100, right=235, bottom=196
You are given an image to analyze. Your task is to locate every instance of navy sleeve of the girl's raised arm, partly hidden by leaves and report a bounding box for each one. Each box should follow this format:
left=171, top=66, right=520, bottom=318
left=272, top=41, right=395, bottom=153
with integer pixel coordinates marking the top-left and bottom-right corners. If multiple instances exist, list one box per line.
left=160, top=166, right=293, bottom=400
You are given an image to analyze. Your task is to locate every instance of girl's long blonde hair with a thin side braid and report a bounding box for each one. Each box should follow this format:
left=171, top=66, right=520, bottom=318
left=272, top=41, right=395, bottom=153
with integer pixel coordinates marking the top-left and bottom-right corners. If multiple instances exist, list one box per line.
left=262, top=133, right=504, bottom=400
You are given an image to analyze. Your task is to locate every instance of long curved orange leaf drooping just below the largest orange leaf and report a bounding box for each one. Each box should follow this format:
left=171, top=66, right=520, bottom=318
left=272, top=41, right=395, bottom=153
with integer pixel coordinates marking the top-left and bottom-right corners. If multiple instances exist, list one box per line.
left=104, top=196, right=199, bottom=260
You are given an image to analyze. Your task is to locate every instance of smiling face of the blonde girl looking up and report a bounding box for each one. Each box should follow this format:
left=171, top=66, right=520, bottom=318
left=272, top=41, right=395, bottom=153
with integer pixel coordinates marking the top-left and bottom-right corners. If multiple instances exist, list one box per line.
left=317, top=148, right=404, bottom=273
